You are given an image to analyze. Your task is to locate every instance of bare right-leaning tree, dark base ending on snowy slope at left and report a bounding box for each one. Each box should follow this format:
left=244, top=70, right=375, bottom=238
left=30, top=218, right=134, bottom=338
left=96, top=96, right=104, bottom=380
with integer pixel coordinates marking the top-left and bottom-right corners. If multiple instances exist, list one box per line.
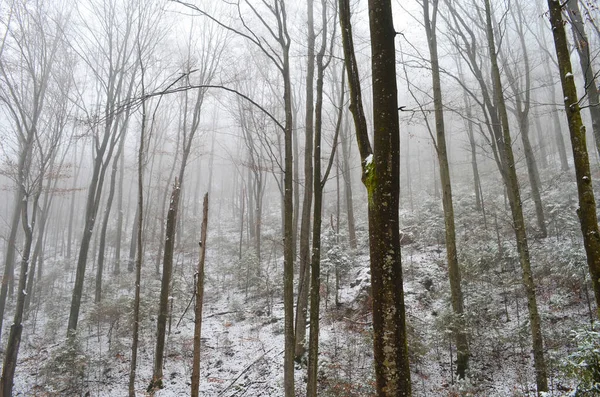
left=67, top=0, right=142, bottom=335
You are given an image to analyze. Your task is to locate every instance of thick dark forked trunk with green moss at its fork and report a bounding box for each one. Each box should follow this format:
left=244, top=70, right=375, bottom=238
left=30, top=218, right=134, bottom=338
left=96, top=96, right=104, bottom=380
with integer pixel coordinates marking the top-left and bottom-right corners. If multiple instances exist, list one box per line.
left=339, top=0, right=411, bottom=397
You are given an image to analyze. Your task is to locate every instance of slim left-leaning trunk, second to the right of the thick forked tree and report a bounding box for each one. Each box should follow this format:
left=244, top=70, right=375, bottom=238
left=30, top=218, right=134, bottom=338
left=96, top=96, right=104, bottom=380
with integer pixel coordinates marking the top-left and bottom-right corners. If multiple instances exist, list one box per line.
left=485, top=0, right=548, bottom=393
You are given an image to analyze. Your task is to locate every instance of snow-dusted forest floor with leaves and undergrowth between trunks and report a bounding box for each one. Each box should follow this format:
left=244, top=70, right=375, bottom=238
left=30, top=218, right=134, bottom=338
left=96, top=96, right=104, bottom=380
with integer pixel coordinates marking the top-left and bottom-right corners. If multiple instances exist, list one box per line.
left=3, top=171, right=593, bottom=397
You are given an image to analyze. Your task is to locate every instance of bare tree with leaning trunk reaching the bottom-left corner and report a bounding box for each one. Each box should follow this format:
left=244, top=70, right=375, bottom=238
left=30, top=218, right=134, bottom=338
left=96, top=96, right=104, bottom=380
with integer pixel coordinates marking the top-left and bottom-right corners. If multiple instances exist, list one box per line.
left=0, top=3, right=72, bottom=390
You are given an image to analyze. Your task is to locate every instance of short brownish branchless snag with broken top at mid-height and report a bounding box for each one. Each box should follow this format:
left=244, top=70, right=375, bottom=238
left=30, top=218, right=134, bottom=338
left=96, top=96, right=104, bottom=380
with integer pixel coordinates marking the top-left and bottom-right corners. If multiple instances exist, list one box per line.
left=191, top=193, right=208, bottom=397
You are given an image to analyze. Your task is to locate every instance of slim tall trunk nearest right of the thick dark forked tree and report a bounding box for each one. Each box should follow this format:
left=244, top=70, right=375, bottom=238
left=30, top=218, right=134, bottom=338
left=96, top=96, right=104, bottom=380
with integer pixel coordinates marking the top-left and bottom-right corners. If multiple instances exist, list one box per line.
left=423, top=0, right=469, bottom=379
